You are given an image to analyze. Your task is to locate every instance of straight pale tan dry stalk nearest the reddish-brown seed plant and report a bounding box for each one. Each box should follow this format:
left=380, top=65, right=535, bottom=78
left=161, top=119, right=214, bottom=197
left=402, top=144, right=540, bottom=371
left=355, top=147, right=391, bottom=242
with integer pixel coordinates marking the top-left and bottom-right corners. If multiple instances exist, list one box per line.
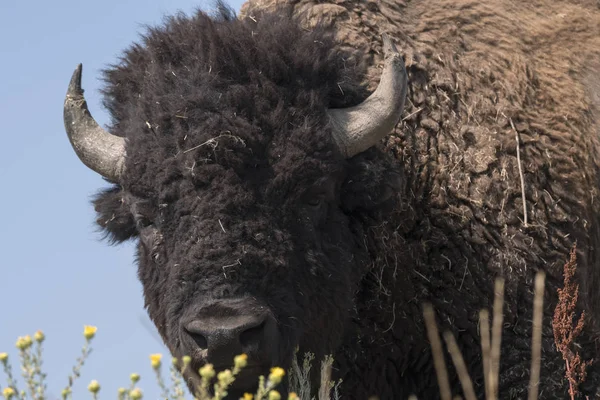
left=528, top=271, right=546, bottom=400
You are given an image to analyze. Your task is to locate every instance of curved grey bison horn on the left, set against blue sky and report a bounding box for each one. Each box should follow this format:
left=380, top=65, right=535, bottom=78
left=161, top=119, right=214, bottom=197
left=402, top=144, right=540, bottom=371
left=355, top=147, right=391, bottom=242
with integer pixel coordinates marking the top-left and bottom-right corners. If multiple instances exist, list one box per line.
left=63, top=64, right=125, bottom=182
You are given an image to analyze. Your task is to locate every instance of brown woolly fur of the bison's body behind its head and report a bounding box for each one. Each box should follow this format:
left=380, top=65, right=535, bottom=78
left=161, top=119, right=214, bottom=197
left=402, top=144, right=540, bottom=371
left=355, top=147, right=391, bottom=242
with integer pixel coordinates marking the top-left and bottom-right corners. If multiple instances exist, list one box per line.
left=243, top=0, right=600, bottom=398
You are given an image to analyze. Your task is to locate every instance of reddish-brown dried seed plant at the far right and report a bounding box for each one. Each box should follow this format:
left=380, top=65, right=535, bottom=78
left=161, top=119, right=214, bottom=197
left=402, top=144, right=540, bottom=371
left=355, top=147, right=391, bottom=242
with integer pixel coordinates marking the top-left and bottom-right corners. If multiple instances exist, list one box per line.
left=552, top=246, right=593, bottom=399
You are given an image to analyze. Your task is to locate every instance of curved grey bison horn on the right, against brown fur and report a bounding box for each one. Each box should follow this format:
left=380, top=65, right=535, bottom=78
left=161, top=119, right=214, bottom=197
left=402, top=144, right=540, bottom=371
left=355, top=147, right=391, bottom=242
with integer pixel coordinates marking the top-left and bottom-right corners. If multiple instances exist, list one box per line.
left=328, top=34, right=408, bottom=158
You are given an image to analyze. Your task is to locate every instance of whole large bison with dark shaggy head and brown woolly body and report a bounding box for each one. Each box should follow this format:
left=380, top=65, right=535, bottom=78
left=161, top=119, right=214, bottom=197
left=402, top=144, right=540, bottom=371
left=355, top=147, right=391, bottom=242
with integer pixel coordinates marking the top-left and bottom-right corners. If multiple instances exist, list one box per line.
left=64, top=0, right=600, bottom=399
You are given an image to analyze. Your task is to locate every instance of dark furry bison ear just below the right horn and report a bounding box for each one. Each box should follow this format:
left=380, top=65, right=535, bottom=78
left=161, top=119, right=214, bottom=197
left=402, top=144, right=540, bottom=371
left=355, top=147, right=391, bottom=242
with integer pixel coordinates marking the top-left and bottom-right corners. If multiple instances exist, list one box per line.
left=342, top=148, right=405, bottom=213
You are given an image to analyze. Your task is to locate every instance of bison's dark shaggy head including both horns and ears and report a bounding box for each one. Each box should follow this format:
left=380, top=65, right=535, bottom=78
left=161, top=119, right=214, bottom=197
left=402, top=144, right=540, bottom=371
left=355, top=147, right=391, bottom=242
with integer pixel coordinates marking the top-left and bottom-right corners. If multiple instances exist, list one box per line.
left=64, top=3, right=407, bottom=395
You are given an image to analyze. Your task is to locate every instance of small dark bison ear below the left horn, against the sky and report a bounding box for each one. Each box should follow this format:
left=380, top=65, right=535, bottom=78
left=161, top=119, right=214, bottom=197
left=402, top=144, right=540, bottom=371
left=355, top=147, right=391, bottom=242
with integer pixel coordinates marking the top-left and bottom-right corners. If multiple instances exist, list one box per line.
left=94, top=186, right=138, bottom=243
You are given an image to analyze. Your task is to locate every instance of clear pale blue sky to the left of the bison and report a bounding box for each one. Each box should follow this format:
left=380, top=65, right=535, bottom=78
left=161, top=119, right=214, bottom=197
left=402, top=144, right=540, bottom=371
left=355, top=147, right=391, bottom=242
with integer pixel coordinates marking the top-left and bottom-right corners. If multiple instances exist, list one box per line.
left=0, top=0, right=241, bottom=399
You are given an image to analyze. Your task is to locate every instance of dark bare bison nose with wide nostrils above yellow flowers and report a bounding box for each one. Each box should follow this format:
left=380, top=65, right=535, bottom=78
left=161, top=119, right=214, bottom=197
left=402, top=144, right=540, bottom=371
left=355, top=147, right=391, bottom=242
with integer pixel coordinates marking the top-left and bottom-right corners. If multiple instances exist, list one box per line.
left=185, top=314, right=269, bottom=367
